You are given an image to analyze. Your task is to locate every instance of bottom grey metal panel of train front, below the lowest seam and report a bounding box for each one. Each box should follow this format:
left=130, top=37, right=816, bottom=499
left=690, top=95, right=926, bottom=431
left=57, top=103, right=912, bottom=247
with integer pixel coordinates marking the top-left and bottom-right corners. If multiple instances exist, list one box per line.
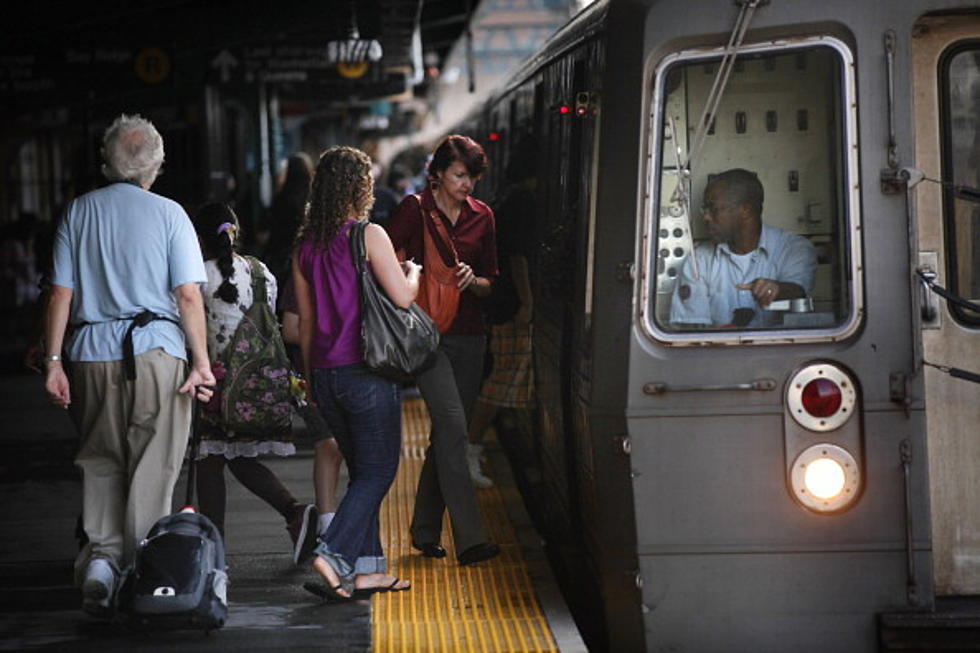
left=641, top=551, right=929, bottom=653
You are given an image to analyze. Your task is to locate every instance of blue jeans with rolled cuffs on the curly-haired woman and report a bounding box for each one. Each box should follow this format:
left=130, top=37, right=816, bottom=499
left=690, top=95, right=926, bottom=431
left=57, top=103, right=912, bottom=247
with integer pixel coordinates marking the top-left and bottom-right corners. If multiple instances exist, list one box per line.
left=313, top=363, right=402, bottom=579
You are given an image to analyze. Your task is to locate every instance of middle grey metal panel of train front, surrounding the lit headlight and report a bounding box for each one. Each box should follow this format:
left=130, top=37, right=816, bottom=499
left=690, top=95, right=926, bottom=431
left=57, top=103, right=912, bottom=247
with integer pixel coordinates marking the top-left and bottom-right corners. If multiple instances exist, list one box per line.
left=631, top=413, right=929, bottom=552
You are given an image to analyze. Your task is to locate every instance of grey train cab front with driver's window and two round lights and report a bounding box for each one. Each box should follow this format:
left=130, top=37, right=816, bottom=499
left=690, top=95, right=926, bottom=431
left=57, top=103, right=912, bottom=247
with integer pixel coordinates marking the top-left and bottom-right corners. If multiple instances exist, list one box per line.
left=627, top=24, right=931, bottom=653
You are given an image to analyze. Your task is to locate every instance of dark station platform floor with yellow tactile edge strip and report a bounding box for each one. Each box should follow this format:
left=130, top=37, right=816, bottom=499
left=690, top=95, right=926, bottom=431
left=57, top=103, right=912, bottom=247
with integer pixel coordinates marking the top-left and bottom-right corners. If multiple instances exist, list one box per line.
left=0, top=373, right=586, bottom=653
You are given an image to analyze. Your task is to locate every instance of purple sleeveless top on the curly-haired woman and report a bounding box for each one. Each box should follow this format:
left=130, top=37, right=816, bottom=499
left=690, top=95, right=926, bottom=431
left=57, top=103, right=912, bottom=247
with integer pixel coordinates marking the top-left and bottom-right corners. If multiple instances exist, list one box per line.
left=296, top=221, right=363, bottom=367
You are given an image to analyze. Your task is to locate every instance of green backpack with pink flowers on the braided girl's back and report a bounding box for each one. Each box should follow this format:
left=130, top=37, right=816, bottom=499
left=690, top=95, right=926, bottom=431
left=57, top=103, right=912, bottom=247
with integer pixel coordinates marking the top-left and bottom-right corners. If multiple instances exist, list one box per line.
left=214, top=256, right=294, bottom=433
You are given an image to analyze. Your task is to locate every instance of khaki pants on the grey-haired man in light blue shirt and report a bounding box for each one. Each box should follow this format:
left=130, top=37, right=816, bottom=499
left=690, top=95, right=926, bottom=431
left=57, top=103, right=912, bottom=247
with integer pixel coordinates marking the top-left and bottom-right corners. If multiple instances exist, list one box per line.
left=71, top=349, right=191, bottom=581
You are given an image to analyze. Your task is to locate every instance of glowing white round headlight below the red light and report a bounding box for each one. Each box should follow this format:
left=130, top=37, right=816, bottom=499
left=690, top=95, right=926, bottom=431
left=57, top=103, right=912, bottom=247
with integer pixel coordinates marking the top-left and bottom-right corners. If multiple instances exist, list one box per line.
left=790, top=443, right=861, bottom=512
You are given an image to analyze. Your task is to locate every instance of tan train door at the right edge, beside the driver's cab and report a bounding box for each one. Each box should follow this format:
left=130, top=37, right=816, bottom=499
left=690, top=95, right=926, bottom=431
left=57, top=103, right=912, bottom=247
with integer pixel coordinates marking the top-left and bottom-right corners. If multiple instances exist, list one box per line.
left=912, top=14, right=980, bottom=596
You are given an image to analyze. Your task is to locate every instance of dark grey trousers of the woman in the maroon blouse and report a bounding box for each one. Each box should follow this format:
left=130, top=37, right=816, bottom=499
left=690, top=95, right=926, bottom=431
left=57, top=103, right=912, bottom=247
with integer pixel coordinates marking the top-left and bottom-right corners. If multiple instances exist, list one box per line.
left=411, top=335, right=487, bottom=555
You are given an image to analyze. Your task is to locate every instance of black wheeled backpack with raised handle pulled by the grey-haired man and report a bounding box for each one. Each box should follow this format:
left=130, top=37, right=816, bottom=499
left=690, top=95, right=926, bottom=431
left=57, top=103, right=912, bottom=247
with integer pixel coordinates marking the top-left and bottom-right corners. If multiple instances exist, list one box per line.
left=117, top=398, right=228, bottom=632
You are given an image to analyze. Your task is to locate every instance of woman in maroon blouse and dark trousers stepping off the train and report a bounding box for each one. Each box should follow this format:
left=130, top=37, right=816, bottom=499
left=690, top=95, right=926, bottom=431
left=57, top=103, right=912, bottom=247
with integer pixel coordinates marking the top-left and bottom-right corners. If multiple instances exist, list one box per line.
left=387, top=135, right=500, bottom=565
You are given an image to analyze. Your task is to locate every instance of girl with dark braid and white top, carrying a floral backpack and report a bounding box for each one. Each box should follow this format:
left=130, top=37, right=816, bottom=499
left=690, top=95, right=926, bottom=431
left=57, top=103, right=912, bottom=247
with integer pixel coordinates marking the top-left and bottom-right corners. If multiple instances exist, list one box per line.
left=194, top=203, right=315, bottom=556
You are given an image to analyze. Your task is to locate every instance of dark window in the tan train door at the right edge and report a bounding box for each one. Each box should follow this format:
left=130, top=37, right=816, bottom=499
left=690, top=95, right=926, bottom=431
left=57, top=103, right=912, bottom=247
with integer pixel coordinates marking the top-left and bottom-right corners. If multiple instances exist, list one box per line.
left=940, top=43, right=980, bottom=325
